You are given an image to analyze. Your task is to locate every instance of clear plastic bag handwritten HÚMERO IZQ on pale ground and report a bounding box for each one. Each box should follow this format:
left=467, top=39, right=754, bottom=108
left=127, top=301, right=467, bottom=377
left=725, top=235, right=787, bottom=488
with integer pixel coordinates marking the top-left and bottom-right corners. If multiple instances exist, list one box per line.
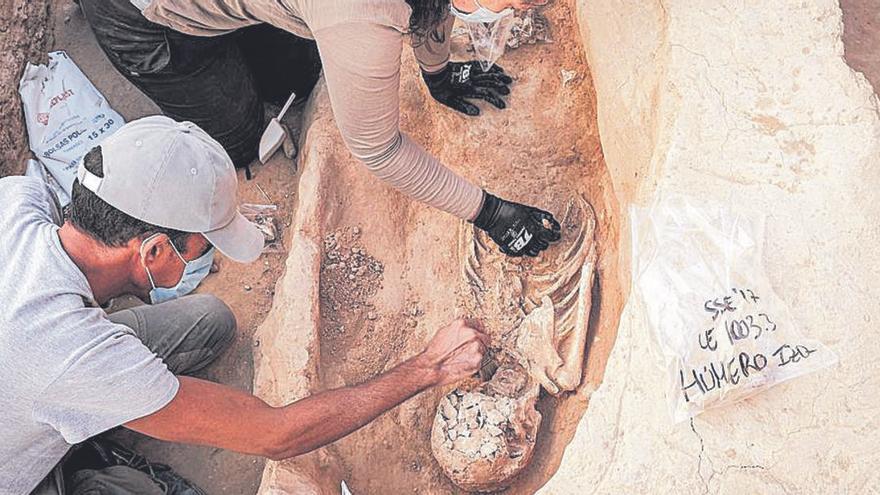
left=630, top=197, right=837, bottom=422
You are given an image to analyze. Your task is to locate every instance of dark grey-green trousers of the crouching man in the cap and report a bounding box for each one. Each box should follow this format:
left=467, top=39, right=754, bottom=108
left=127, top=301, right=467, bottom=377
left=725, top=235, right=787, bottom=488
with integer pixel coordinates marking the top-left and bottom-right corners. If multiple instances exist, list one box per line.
left=31, top=294, right=235, bottom=495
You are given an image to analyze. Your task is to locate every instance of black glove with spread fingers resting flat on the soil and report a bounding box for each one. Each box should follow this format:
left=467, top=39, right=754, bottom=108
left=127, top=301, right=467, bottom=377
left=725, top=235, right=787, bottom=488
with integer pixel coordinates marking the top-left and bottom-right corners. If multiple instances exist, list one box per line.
left=422, top=62, right=513, bottom=116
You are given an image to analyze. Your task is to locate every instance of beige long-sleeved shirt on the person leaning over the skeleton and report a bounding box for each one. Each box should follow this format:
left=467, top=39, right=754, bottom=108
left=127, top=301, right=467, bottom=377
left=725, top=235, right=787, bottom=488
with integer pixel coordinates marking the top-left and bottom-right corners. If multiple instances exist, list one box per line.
left=132, top=0, right=483, bottom=220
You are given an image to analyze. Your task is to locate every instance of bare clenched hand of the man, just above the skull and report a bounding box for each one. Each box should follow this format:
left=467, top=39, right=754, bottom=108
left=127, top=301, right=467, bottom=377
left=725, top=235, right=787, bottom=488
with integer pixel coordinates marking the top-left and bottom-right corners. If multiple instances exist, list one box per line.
left=416, top=320, right=489, bottom=385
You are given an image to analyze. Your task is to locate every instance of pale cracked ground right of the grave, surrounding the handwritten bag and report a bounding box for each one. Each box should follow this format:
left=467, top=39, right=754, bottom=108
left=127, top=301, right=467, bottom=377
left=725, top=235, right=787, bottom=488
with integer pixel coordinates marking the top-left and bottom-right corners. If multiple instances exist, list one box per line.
left=541, top=0, right=880, bottom=494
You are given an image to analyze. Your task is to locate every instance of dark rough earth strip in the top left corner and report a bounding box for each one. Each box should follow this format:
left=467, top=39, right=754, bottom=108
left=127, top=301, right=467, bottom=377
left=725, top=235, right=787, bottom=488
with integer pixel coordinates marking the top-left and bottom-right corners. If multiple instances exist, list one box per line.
left=0, top=0, right=52, bottom=177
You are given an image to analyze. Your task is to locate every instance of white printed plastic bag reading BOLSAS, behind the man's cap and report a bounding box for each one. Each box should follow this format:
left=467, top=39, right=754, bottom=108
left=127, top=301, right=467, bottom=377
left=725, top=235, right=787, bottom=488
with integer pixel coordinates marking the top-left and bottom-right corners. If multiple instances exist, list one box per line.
left=18, top=51, right=125, bottom=205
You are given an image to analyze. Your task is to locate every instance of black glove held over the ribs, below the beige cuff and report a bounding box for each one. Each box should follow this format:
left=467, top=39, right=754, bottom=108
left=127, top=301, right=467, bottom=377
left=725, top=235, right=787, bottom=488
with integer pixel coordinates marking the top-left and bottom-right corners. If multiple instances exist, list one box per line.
left=474, top=193, right=561, bottom=256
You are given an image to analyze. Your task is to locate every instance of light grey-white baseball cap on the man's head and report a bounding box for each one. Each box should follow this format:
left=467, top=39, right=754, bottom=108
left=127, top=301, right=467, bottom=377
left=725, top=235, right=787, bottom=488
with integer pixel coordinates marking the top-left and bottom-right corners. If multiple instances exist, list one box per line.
left=77, top=115, right=263, bottom=263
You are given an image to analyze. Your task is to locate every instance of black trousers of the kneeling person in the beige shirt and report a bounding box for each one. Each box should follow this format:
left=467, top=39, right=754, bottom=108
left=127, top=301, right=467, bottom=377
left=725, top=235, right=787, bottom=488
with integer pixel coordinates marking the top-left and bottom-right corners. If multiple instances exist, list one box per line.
left=80, top=0, right=321, bottom=167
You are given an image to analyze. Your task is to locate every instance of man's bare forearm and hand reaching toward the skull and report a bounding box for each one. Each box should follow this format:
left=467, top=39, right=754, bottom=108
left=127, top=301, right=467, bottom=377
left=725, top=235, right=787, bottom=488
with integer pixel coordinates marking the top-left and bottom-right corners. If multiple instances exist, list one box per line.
left=125, top=321, right=488, bottom=460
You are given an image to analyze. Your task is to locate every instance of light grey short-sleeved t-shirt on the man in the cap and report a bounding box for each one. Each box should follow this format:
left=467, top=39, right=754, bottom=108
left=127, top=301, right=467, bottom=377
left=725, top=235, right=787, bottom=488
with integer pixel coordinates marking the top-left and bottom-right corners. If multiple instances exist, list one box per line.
left=0, top=177, right=178, bottom=494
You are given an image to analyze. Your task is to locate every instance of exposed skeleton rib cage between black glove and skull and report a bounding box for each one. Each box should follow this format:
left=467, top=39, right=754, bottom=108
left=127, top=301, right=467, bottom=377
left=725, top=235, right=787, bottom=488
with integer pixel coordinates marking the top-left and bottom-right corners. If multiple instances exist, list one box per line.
left=459, top=196, right=597, bottom=394
